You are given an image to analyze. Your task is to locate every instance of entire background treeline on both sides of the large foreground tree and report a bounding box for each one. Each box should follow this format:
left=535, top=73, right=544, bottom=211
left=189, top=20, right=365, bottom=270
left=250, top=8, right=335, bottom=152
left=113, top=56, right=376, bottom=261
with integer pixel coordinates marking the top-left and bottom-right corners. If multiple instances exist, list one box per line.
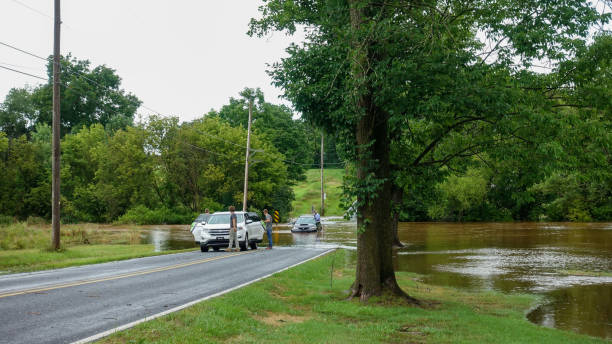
left=0, top=43, right=612, bottom=223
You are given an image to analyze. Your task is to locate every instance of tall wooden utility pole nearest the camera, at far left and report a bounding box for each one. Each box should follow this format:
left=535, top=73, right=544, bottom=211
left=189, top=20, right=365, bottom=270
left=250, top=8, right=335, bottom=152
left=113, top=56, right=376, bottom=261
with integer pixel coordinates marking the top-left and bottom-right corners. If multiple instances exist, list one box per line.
left=51, top=0, right=62, bottom=251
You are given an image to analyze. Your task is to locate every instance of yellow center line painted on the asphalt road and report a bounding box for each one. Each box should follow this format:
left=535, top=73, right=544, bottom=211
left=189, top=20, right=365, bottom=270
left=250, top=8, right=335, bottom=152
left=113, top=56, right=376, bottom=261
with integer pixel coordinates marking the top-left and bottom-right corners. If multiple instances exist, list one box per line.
left=0, top=251, right=253, bottom=299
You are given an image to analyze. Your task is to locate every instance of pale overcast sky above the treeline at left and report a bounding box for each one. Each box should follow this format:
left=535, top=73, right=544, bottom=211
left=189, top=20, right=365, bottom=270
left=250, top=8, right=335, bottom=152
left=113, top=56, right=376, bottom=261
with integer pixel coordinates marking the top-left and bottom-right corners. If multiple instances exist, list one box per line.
left=0, top=0, right=302, bottom=121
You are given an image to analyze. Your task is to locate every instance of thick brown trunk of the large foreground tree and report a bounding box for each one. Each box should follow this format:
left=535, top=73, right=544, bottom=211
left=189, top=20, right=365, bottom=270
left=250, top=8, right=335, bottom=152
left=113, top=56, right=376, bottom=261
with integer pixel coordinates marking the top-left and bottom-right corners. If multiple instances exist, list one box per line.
left=349, top=0, right=419, bottom=304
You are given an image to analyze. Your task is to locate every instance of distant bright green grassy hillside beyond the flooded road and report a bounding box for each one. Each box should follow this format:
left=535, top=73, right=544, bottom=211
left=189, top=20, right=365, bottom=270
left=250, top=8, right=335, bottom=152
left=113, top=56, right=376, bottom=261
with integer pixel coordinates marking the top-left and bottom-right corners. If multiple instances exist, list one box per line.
left=291, top=169, right=344, bottom=217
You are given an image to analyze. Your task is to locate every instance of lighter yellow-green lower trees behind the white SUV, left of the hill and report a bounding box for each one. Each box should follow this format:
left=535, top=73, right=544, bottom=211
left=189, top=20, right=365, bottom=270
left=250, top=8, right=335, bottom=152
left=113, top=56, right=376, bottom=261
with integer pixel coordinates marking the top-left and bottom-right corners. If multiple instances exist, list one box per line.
left=0, top=84, right=298, bottom=224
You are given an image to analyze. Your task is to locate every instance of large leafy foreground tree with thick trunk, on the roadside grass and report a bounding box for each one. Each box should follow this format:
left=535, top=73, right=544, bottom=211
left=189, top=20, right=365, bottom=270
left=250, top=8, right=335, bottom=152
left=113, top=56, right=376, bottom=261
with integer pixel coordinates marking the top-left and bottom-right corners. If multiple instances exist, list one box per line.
left=250, top=0, right=608, bottom=302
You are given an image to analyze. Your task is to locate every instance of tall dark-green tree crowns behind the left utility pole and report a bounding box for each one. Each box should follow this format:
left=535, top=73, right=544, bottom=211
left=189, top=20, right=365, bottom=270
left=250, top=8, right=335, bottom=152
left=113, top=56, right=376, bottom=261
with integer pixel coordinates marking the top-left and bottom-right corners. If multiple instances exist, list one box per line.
left=0, top=54, right=141, bottom=138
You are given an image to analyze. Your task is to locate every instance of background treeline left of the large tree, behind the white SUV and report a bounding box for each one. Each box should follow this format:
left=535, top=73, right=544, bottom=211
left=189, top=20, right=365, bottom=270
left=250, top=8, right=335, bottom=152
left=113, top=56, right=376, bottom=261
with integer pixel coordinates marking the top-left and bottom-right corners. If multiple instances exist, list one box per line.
left=0, top=56, right=338, bottom=223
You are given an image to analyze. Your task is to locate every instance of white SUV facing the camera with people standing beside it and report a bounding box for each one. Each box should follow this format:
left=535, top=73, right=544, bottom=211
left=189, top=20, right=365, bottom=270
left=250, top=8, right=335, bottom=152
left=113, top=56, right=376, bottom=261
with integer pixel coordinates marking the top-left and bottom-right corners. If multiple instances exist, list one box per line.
left=200, top=211, right=264, bottom=252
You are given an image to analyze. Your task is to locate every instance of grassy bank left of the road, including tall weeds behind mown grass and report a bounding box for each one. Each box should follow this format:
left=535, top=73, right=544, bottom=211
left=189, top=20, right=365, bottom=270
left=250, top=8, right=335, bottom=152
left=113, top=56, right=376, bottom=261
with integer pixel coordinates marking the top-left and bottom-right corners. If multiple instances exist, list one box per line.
left=0, top=223, right=195, bottom=274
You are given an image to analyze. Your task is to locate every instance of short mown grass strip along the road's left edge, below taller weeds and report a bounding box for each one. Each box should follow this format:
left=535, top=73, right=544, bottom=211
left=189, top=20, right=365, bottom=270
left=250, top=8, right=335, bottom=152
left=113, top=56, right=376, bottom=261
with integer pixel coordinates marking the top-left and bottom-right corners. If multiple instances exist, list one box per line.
left=0, top=244, right=193, bottom=274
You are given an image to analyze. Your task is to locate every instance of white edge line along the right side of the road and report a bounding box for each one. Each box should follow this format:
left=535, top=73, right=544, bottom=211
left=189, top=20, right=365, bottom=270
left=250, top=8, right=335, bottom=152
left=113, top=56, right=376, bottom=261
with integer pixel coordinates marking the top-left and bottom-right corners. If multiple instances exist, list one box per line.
left=72, top=249, right=336, bottom=344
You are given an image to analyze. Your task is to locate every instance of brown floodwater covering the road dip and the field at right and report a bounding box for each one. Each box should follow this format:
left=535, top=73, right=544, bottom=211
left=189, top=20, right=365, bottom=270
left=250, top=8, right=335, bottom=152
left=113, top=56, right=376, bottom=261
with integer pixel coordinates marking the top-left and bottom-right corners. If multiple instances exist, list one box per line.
left=136, top=219, right=612, bottom=339
